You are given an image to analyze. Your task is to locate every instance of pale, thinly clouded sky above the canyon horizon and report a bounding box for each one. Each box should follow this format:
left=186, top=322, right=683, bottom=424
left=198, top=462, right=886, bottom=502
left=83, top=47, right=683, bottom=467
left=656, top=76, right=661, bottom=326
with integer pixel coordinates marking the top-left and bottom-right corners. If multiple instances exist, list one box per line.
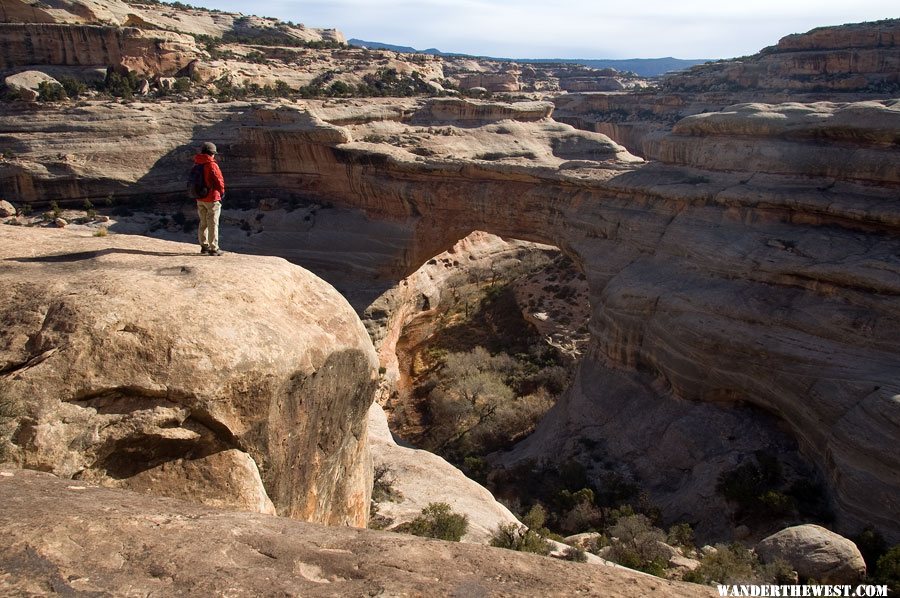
left=186, top=0, right=900, bottom=59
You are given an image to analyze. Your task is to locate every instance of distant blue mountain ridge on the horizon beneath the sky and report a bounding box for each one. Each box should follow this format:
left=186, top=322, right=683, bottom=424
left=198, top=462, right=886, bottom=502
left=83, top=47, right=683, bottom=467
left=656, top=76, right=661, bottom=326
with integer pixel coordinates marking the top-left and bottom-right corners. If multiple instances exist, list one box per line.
left=348, top=39, right=713, bottom=77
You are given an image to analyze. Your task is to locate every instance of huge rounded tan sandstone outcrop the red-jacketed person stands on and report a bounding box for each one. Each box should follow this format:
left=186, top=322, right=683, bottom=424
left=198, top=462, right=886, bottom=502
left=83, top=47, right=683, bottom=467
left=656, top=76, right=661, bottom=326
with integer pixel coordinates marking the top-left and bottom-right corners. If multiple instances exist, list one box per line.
left=0, top=226, right=377, bottom=526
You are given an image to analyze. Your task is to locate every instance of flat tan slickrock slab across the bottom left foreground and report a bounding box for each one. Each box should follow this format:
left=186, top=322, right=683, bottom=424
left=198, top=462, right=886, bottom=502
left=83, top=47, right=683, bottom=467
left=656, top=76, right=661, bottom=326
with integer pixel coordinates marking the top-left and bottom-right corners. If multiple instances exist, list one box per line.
left=0, top=469, right=715, bottom=598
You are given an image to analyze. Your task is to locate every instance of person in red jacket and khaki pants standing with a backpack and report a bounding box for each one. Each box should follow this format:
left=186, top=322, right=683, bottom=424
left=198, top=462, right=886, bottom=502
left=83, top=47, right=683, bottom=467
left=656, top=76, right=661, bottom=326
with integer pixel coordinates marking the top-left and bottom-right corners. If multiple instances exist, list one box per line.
left=189, top=141, right=225, bottom=255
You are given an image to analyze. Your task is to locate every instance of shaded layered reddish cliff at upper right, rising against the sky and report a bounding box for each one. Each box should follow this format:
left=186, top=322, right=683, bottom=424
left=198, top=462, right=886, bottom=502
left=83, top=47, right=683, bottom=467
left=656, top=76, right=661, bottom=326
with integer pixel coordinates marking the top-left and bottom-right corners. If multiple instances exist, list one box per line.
left=554, top=19, right=900, bottom=157
